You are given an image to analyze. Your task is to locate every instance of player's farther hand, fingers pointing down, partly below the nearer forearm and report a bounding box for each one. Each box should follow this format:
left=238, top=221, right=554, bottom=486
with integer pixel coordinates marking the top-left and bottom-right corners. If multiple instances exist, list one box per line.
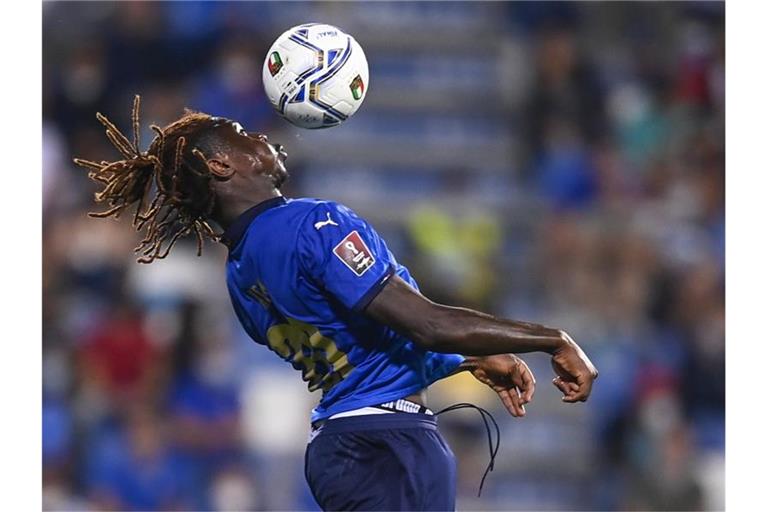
left=472, top=354, right=536, bottom=418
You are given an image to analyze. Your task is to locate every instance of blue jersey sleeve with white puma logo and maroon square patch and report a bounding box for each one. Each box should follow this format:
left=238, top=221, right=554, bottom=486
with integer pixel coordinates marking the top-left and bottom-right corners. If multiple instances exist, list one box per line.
left=297, top=203, right=395, bottom=311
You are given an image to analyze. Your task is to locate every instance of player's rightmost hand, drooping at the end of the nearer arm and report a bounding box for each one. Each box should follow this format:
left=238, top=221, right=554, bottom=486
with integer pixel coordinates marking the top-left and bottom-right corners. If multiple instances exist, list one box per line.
left=552, top=331, right=597, bottom=403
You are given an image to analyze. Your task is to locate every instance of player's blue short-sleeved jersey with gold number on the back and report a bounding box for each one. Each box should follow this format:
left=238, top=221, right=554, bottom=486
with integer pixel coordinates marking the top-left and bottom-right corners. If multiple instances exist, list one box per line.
left=224, top=197, right=464, bottom=421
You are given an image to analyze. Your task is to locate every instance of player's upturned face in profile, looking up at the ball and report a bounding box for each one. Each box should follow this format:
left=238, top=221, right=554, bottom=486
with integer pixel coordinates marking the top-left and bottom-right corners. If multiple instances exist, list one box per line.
left=216, top=121, right=288, bottom=187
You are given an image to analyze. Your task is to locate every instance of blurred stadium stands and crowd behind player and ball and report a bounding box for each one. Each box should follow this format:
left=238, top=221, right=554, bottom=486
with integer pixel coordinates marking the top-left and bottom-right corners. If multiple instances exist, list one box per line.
left=42, top=2, right=725, bottom=510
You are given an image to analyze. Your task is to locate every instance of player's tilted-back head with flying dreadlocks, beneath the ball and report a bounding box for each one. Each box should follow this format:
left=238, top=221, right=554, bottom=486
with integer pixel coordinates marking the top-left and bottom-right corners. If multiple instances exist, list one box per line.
left=75, top=96, right=288, bottom=263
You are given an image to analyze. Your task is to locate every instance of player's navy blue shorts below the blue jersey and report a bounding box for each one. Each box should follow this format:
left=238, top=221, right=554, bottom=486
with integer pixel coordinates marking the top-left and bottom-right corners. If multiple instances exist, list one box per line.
left=304, top=413, right=456, bottom=510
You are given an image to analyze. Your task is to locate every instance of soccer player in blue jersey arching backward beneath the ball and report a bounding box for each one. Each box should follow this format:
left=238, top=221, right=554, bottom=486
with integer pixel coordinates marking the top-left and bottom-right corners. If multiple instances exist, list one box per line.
left=75, top=96, right=597, bottom=510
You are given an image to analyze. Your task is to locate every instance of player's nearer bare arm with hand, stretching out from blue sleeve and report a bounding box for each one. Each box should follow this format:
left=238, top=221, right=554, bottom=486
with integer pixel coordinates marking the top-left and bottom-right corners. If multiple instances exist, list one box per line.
left=365, top=276, right=597, bottom=402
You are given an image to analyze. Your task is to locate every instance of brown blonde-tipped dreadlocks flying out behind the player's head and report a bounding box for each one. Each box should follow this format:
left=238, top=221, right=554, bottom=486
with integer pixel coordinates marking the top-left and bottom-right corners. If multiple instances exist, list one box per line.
left=74, top=95, right=218, bottom=263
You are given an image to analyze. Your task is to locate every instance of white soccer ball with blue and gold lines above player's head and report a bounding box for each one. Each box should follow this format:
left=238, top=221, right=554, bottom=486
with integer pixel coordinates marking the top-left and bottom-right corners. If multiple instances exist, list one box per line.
left=262, top=23, right=368, bottom=128
